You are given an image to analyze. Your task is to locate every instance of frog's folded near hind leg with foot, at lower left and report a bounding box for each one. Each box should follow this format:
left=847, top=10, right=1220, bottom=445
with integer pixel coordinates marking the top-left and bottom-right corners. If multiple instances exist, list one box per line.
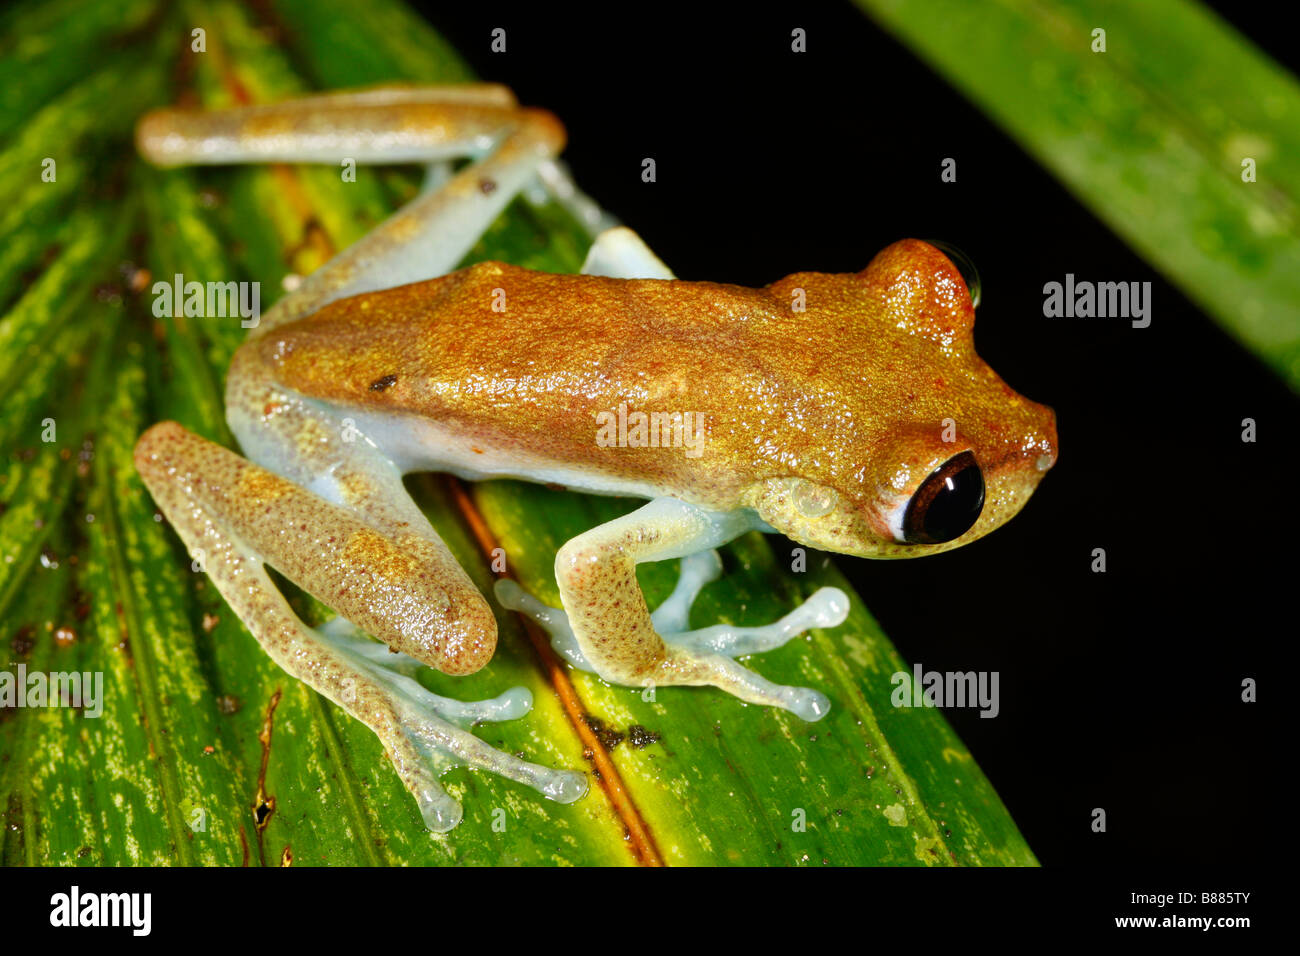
left=135, top=421, right=586, bottom=831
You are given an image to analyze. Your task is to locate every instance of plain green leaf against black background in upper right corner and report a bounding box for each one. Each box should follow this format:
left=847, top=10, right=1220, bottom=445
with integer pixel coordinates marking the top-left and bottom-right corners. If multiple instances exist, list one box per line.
left=857, top=0, right=1300, bottom=392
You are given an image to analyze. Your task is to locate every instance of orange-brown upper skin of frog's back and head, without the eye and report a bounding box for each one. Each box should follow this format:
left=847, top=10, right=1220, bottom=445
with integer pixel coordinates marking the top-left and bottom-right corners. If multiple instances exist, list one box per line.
left=261, top=239, right=1056, bottom=557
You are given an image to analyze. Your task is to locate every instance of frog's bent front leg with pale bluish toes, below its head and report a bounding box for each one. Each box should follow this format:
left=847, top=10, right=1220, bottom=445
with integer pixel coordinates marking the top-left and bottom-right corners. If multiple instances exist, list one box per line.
left=497, top=498, right=848, bottom=721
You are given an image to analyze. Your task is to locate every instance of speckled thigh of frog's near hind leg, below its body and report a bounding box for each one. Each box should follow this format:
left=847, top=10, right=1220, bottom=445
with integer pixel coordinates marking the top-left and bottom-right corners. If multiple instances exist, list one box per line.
left=137, top=423, right=497, bottom=674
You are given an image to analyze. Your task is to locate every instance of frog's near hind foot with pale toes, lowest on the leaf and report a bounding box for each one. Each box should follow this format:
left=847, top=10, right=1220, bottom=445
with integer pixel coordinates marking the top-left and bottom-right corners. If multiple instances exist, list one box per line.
left=316, top=618, right=586, bottom=832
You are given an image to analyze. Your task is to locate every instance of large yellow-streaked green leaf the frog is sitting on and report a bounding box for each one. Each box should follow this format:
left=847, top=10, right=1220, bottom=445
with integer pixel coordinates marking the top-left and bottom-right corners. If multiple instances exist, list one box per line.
left=0, top=0, right=1035, bottom=865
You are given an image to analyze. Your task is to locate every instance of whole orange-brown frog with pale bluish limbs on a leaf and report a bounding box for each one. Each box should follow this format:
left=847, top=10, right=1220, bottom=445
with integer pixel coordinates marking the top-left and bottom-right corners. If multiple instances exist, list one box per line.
left=134, top=83, right=1058, bottom=832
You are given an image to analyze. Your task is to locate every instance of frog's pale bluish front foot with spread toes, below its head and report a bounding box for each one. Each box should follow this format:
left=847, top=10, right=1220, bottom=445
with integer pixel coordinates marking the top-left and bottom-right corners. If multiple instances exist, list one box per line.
left=495, top=550, right=849, bottom=721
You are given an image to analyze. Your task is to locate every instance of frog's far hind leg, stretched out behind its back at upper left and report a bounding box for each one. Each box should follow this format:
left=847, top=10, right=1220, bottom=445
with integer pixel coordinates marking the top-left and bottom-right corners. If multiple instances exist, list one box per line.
left=137, top=85, right=610, bottom=336
